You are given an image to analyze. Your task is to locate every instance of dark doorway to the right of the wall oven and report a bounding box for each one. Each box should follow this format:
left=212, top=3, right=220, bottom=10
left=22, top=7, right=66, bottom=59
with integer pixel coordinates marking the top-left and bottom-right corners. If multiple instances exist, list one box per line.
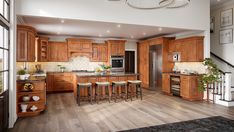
left=125, top=51, right=135, bottom=73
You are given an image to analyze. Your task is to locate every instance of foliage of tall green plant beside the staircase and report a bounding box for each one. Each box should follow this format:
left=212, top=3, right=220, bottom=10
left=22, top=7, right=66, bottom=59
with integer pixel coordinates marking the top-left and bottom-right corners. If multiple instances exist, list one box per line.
left=198, top=58, right=220, bottom=91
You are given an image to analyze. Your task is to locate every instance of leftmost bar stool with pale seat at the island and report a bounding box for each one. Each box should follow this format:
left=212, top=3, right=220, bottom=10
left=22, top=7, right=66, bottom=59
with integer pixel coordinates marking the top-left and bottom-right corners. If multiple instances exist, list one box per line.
left=77, top=83, right=93, bottom=106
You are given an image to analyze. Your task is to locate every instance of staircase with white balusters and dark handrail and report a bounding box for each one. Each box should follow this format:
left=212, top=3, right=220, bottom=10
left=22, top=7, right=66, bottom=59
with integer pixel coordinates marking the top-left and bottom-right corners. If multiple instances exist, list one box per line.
left=208, top=53, right=234, bottom=107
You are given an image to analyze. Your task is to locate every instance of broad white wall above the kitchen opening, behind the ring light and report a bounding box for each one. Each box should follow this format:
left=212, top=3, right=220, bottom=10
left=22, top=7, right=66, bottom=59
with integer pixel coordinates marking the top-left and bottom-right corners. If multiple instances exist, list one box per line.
left=16, top=0, right=210, bottom=30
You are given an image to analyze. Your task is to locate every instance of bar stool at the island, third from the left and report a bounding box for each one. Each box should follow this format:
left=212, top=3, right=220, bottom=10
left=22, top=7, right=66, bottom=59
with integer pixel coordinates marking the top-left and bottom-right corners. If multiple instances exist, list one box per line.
left=111, top=81, right=128, bottom=102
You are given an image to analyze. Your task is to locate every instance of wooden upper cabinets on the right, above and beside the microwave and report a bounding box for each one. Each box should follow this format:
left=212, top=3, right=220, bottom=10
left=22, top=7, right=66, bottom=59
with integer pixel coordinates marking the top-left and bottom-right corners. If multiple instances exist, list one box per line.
left=169, top=37, right=204, bottom=62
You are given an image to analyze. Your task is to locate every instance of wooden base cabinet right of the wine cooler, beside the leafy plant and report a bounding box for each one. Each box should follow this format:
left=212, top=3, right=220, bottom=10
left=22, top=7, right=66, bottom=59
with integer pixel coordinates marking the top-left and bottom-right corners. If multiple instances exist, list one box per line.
left=180, top=75, right=203, bottom=101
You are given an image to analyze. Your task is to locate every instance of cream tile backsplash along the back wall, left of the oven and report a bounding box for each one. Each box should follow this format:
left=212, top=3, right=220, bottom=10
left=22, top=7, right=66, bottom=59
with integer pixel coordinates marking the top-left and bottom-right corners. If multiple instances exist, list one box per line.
left=17, top=57, right=103, bottom=73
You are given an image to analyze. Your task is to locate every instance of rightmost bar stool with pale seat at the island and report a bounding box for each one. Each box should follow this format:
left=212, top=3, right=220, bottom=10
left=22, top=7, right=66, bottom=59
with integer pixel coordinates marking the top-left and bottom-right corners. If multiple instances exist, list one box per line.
left=127, top=80, right=142, bottom=101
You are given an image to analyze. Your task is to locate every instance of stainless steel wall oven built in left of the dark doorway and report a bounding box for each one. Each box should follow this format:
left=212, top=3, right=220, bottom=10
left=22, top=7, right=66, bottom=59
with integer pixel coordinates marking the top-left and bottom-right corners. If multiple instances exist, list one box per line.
left=110, top=56, right=125, bottom=72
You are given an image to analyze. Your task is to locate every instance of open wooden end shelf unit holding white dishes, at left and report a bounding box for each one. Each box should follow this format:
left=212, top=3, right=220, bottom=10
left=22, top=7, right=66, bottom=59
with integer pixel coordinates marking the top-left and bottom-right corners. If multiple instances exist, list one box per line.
left=16, top=80, right=46, bottom=117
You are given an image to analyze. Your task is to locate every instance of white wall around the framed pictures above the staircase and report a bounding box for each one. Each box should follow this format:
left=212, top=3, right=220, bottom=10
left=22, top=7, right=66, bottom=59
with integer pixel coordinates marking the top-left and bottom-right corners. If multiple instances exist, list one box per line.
left=211, top=1, right=234, bottom=65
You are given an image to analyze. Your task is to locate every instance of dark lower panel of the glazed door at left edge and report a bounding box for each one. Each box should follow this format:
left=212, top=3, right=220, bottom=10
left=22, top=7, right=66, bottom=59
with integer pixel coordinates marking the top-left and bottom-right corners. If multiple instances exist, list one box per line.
left=0, top=90, right=9, bottom=132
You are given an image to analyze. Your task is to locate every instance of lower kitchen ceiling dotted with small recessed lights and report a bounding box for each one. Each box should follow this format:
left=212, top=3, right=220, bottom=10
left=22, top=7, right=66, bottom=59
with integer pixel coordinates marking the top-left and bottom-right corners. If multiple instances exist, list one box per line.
left=18, top=16, right=194, bottom=39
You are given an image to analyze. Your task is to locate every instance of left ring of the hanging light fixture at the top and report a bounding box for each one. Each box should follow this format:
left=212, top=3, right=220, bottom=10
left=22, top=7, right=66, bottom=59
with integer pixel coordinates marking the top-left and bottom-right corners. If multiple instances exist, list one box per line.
left=126, top=0, right=174, bottom=10
